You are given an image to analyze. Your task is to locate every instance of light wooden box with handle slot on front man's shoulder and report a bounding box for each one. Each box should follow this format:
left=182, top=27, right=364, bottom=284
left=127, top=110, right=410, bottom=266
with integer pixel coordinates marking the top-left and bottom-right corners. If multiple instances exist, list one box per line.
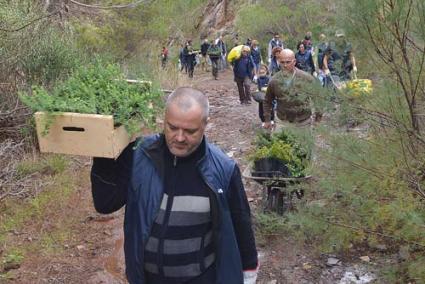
left=35, top=112, right=130, bottom=158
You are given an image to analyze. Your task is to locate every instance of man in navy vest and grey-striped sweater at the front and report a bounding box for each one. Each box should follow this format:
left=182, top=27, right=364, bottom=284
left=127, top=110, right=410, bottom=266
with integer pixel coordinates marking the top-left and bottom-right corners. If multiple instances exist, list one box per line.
left=91, top=87, right=258, bottom=284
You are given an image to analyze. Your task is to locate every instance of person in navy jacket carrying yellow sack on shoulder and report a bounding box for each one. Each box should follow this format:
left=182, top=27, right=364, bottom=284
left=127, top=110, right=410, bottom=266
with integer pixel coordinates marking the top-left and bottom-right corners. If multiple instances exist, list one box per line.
left=232, top=45, right=255, bottom=104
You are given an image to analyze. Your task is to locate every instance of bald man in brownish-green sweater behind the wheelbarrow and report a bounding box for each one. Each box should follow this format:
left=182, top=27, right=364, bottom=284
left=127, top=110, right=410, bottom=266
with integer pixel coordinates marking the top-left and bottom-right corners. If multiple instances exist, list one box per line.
left=263, top=49, right=314, bottom=129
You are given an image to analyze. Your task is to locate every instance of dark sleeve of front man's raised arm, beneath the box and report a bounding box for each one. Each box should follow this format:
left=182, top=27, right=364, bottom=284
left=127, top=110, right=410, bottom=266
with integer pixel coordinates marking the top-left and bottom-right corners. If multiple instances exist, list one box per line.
left=90, top=143, right=134, bottom=214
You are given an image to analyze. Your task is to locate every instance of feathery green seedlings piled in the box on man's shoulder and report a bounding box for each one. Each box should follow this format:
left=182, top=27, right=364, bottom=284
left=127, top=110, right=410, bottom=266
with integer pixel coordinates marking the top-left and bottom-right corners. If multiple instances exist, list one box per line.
left=21, top=59, right=162, bottom=135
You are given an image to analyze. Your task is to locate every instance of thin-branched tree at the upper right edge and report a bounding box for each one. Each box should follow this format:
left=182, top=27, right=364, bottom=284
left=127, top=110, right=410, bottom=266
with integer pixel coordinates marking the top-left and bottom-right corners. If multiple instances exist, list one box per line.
left=345, top=0, right=425, bottom=134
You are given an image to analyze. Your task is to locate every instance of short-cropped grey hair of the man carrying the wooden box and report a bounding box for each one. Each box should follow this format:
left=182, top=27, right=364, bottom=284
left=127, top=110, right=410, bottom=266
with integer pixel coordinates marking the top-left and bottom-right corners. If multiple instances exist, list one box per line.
left=165, top=87, right=209, bottom=122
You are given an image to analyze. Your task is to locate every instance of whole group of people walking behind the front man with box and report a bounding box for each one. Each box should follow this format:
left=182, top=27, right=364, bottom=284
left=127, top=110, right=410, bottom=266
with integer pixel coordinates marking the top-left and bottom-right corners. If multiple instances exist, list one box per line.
left=170, top=30, right=357, bottom=128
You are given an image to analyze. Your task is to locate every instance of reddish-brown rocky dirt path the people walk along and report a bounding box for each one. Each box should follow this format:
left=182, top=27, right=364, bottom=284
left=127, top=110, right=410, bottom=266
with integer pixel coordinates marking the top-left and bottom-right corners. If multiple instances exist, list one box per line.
left=5, top=67, right=373, bottom=284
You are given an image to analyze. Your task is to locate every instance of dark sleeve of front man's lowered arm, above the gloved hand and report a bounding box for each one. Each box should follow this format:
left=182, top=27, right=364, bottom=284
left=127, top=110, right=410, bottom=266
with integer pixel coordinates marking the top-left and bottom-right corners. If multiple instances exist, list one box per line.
left=229, top=165, right=258, bottom=270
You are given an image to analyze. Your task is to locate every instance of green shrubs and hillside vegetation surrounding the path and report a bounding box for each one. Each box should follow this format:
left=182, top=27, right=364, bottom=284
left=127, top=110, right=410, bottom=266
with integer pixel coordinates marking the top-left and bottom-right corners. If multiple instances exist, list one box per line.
left=0, top=0, right=425, bottom=283
